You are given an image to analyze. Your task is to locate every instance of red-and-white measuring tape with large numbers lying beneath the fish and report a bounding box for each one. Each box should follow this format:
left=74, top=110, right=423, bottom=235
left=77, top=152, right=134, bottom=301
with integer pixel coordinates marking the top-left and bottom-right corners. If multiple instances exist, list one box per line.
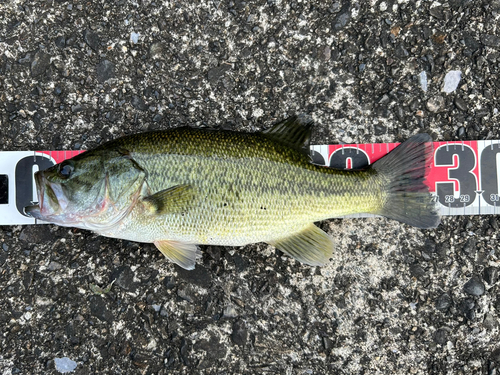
left=0, top=140, right=500, bottom=225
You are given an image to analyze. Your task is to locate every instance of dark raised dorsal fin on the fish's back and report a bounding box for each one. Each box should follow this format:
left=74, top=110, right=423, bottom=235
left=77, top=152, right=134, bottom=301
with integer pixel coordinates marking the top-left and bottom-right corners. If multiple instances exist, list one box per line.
left=263, top=115, right=313, bottom=154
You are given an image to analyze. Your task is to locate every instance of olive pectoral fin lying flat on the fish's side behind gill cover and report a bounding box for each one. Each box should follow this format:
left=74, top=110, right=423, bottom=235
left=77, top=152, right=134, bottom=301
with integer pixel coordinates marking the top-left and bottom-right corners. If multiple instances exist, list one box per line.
left=143, top=185, right=195, bottom=214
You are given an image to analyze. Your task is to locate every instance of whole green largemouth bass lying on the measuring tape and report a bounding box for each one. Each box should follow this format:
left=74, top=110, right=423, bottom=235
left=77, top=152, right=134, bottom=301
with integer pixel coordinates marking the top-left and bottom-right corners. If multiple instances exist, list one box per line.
left=25, top=115, right=440, bottom=270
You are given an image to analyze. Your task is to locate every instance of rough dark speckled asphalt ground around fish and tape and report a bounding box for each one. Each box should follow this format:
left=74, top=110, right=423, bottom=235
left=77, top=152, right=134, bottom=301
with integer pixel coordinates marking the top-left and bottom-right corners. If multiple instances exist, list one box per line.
left=0, top=0, right=500, bottom=374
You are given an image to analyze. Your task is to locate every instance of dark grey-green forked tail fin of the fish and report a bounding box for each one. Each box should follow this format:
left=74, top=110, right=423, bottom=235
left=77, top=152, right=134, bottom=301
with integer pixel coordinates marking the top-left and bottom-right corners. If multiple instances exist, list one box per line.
left=372, top=134, right=441, bottom=228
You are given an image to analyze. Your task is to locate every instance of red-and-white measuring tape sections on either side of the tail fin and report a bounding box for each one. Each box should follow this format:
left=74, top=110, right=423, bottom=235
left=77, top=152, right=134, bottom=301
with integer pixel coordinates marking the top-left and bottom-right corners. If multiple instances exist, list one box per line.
left=311, top=140, right=500, bottom=216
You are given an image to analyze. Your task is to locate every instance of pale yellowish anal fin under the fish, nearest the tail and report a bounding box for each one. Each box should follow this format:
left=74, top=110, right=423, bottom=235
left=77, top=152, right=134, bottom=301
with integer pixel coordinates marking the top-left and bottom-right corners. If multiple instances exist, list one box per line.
left=269, top=224, right=333, bottom=266
